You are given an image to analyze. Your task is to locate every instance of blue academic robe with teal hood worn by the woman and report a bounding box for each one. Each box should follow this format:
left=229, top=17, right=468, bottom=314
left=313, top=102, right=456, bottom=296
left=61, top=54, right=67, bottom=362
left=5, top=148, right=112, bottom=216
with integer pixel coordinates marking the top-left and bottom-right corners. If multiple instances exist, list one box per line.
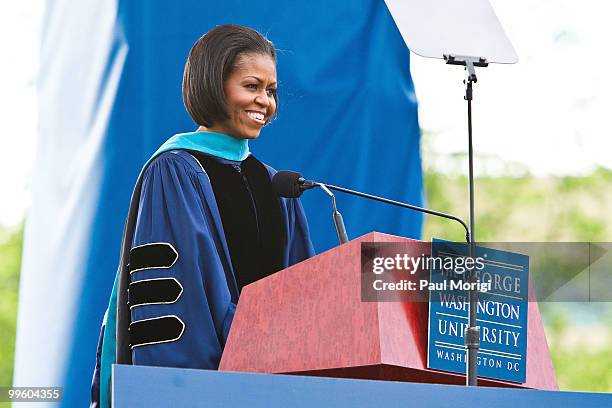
left=92, top=132, right=314, bottom=407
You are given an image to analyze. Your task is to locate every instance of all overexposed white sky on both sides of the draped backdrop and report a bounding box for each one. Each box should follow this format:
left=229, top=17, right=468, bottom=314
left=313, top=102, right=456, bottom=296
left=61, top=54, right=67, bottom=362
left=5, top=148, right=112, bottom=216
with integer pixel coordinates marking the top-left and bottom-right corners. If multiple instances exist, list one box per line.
left=0, top=0, right=612, bottom=226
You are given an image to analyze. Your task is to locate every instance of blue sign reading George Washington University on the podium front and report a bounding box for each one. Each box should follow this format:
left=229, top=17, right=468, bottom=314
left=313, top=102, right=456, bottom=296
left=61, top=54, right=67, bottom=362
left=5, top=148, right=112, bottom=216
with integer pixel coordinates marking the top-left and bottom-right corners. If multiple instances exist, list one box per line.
left=427, top=239, right=529, bottom=383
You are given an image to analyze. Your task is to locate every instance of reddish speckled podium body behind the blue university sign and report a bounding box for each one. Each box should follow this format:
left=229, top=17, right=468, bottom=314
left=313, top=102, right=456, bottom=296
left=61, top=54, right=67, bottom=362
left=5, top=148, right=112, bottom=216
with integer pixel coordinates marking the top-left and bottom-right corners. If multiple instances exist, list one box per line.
left=219, top=232, right=558, bottom=390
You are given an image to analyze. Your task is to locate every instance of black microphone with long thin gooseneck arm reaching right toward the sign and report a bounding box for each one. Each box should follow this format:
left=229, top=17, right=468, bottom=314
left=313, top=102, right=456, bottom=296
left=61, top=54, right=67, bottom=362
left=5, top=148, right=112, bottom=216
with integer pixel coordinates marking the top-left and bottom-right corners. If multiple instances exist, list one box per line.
left=272, top=170, right=470, bottom=243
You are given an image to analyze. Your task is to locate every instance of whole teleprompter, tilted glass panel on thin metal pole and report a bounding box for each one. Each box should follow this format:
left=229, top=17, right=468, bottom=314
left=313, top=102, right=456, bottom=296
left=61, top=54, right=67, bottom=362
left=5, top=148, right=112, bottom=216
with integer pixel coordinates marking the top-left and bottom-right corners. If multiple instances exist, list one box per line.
left=385, top=0, right=518, bottom=385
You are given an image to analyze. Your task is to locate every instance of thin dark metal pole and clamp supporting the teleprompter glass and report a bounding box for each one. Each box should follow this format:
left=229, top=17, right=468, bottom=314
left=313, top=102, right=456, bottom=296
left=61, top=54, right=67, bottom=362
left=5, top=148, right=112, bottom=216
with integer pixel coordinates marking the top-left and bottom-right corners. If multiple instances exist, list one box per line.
left=444, top=55, right=488, bottom=386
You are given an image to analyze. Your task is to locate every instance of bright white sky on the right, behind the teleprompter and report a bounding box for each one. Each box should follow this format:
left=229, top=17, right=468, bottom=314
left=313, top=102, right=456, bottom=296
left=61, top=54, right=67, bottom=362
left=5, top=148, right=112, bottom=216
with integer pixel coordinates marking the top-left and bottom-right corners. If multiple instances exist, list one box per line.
left=411, top=0, right=612, bottom=176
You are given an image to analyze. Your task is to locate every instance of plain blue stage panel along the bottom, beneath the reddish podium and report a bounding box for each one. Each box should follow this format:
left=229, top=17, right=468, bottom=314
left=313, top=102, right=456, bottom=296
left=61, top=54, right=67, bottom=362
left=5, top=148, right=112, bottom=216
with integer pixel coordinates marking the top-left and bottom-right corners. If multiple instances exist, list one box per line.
left=113, top=365, right=612, bottom=408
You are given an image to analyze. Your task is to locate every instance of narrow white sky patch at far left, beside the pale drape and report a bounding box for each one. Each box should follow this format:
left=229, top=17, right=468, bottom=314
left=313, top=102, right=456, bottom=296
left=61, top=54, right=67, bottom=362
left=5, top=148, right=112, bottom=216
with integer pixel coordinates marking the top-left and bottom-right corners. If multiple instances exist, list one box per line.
left=0, top=0, right=43, bottom=226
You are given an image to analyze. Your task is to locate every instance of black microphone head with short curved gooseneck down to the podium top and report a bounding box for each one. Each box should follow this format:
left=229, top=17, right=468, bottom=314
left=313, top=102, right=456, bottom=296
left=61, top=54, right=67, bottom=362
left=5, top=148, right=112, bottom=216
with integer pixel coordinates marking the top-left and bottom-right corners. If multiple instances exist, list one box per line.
left=272, top=170, right=348, bottom=244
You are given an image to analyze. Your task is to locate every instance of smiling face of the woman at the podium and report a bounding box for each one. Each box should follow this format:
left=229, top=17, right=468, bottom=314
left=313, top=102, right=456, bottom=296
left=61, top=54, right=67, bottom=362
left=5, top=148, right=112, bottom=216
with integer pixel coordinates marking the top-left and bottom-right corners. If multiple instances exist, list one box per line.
left=211, top=54, right=276, bottom=139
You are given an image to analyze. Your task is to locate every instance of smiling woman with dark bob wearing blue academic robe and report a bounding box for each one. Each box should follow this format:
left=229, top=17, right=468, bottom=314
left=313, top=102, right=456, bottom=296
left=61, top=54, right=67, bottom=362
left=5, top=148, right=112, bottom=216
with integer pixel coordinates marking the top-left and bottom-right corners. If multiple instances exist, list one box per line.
left=92, top=25, right=314, bottom=406
